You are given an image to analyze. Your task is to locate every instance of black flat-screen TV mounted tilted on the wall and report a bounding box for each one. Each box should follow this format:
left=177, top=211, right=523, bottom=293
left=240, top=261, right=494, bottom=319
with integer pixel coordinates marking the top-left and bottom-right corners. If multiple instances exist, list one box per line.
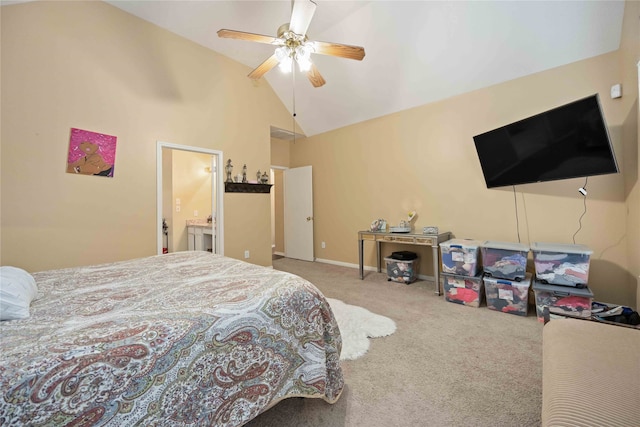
left=473, top=94, right=618, bottom=188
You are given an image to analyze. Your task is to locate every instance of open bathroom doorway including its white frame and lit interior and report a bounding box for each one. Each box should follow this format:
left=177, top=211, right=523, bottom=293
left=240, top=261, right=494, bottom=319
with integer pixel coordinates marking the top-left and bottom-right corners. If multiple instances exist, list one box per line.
left=156, top=141, right=224, bottom=255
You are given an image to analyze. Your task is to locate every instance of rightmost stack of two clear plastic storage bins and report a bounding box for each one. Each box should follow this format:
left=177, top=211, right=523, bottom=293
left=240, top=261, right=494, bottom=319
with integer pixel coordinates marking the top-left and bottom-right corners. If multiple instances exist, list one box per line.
left=531, top=243, right=593, bottom=322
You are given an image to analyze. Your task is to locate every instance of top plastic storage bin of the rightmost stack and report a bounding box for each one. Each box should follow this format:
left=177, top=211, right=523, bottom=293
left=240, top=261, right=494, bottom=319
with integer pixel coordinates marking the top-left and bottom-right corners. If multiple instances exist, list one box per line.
left=531, top=242, right=593, bottom=287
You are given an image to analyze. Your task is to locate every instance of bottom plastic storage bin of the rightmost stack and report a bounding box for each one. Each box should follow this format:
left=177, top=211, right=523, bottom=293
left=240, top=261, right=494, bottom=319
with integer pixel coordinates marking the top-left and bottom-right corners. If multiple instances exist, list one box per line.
left=533, top=280, right=593, bottom=322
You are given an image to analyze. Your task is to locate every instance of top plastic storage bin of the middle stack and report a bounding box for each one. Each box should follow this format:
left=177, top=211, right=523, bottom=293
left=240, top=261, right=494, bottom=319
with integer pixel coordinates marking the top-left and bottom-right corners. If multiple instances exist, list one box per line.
left=480, top=241, right=529, bottom=281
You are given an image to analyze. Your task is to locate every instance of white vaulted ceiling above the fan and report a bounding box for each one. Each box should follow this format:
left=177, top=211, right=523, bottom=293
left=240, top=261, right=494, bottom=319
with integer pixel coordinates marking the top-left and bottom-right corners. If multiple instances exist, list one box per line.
left=108, top=0, right=624, bottom=136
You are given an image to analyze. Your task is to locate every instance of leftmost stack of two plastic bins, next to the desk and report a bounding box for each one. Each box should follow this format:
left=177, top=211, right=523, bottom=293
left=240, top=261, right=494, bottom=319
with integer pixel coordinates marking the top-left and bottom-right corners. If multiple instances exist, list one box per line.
left=440, top=239, right=484, bottom=307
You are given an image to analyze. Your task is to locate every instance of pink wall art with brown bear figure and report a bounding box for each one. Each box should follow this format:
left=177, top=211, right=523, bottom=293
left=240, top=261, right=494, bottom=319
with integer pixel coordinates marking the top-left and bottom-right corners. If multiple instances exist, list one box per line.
left=67, top=128, right=118, bottom=178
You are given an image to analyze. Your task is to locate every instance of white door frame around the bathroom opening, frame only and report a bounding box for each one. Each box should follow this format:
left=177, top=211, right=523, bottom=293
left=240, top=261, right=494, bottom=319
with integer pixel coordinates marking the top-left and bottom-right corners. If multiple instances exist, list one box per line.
left=156, top=141, right=224, bottom=255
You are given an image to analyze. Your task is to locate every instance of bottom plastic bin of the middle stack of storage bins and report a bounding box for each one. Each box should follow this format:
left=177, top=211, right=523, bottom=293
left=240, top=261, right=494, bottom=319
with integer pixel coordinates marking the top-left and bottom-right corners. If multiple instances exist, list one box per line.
left=482, top=273, right=531, bottom=316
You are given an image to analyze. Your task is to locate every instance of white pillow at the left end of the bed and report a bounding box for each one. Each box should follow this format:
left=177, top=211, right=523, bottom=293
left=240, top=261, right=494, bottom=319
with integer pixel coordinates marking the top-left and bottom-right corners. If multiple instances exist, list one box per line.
left=0, top=266, right=38, bottom=320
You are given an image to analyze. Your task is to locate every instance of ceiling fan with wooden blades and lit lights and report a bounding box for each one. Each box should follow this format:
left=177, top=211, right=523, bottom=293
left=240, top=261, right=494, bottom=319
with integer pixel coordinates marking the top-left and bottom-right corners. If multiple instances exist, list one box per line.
left=218, top=0, right=364, bottom=87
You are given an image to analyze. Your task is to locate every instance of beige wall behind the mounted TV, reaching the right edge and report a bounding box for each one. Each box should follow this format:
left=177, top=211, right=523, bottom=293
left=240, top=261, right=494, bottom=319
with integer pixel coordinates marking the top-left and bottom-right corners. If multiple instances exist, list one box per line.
left=291, top=4, right=639, bottom=306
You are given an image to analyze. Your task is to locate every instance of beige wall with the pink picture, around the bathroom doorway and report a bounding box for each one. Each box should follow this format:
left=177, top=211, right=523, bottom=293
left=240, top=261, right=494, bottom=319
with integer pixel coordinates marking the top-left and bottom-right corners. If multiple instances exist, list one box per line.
left=0, top=1, right=291, bottom=271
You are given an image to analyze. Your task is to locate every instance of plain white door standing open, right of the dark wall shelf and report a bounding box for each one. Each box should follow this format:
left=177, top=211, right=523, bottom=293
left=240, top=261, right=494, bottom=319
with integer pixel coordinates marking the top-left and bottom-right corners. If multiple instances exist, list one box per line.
left=284, top=166, right=313, bottom=261
